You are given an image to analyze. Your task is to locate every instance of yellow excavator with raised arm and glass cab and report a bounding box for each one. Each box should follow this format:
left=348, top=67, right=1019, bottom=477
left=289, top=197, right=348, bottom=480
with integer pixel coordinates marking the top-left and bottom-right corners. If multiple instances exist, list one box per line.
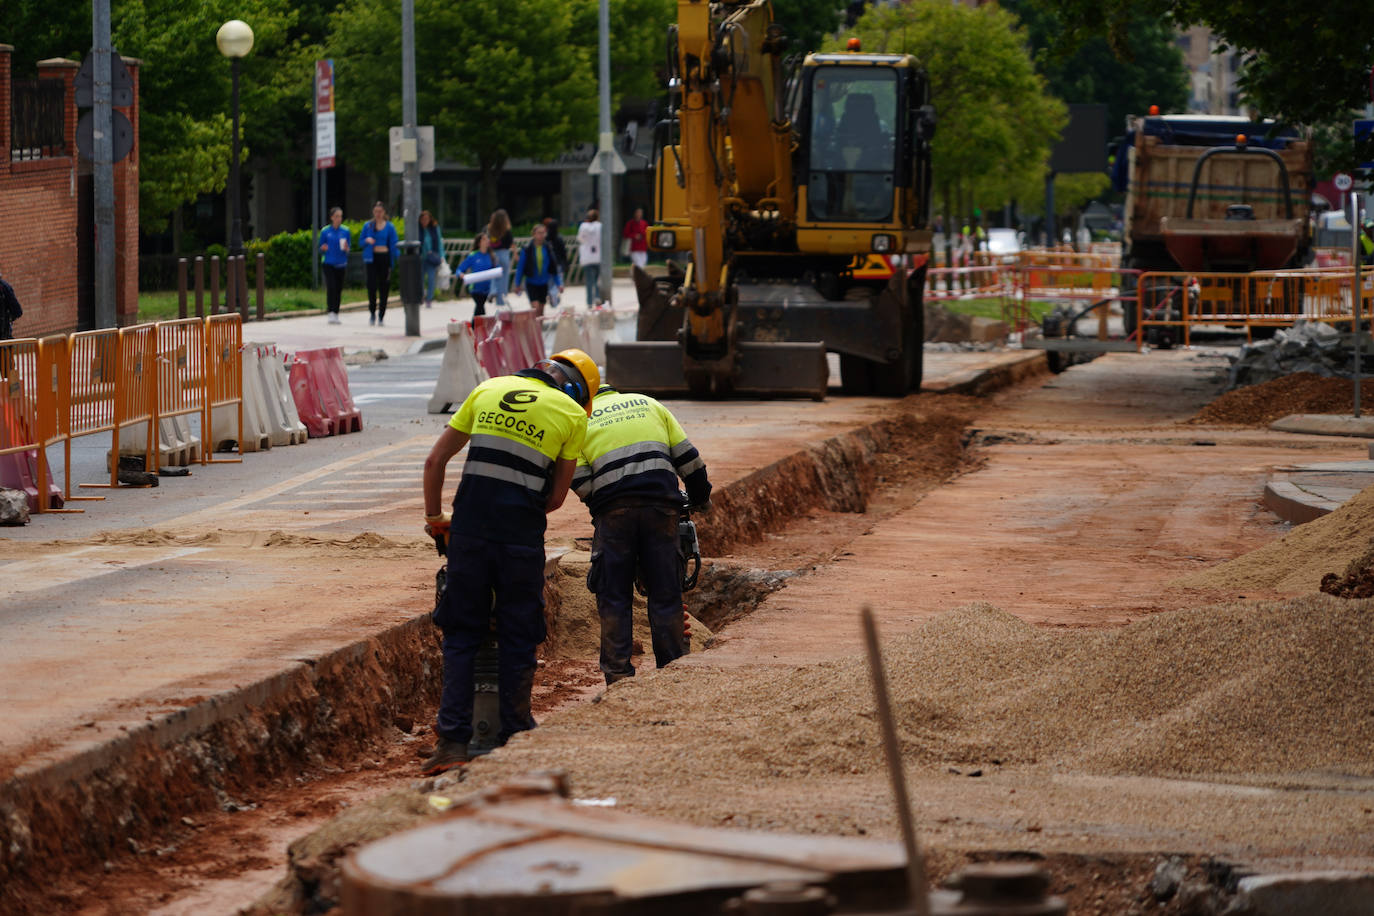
left=606, top=0, right=936, bottom=400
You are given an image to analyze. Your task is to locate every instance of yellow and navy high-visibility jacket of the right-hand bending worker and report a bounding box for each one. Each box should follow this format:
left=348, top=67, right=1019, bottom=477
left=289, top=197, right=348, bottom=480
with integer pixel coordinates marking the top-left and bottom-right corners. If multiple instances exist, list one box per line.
left=573, top=385, right=710, bottom=516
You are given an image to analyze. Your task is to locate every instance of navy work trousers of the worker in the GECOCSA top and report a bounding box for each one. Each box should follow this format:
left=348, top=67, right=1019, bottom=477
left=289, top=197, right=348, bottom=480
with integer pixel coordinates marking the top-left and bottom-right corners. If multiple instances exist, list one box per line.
left=434, top=534, right=547, bottom=744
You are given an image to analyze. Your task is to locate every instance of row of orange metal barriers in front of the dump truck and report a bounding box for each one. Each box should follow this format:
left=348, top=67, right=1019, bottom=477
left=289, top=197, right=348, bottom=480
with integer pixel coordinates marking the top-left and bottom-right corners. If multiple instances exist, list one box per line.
left=1139, top=269, right=1374, bottom=345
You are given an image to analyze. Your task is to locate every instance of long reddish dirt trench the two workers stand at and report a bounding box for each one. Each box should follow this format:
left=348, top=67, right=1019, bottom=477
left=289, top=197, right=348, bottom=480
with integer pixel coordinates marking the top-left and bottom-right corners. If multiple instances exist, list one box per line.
left=0, top=394, right=978, bottom=913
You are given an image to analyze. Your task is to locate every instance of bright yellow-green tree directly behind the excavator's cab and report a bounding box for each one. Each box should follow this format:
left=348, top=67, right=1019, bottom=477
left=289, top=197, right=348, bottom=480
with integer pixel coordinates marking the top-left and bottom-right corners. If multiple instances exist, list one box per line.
left=829, top=3, right=1068, bottom=233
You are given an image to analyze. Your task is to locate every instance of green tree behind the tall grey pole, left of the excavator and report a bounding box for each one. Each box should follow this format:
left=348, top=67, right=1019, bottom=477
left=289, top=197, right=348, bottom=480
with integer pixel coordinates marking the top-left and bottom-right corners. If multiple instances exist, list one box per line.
left=328, top=0, right=596, bottom=211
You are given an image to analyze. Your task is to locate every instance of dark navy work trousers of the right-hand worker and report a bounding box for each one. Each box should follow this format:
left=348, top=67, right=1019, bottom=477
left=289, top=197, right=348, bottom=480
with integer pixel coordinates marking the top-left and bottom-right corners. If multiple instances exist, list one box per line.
left=588, top=505, right=687, bottom=684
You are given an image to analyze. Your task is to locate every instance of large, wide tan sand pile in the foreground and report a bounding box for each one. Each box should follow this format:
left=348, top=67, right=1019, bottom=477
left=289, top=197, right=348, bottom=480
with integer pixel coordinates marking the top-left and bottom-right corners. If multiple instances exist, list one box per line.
left=470, top=595, right=1374, bottom=798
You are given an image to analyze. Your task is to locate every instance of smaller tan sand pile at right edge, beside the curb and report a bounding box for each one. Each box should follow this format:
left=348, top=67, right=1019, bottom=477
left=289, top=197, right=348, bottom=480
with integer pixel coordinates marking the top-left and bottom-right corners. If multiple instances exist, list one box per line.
left=1169, top=486, right=1374, bottom=595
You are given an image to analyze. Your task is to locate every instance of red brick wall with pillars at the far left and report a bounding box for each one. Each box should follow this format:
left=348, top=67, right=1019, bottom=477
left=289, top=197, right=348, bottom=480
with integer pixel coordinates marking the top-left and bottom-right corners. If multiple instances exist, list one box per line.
left=0, top=44, right=139, bottom=336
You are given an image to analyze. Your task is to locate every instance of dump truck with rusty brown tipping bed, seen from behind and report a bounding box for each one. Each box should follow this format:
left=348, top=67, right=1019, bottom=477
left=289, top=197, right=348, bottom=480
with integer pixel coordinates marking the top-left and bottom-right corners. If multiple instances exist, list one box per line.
left=1113, top=114, right=1312, bottom=332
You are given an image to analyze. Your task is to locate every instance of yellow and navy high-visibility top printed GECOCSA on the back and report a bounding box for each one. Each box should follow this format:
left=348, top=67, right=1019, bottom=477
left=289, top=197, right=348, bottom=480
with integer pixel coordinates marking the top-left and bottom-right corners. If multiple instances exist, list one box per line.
left=448, top=369, right=587, bottom=547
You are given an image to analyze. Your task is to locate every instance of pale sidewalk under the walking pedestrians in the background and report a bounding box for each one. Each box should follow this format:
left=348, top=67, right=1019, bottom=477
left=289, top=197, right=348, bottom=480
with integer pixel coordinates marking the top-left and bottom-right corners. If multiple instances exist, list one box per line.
left=243, top=277, right=639, bottom=356
